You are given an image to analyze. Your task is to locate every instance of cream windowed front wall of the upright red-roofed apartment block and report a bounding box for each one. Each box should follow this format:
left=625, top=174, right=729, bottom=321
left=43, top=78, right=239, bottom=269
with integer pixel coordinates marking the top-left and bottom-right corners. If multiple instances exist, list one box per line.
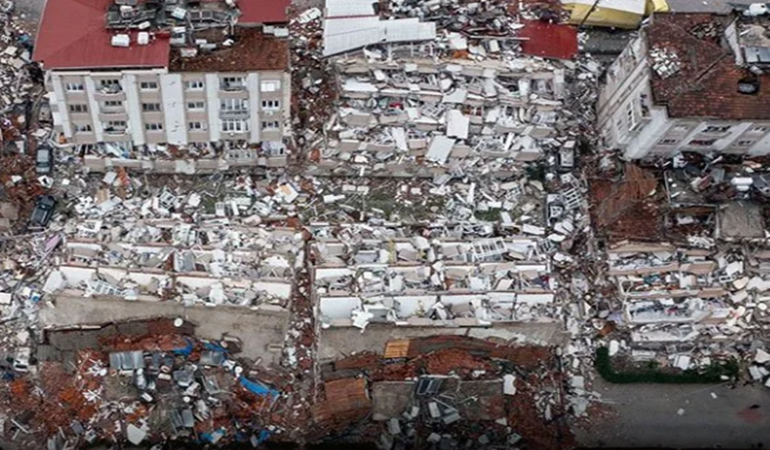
left=46, top=69, right=291, bottom=145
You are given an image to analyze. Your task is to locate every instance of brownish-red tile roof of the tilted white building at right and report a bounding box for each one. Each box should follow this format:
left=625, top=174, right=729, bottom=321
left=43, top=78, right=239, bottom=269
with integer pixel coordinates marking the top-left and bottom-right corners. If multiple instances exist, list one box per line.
left=646, top=14, right=770, bottom=120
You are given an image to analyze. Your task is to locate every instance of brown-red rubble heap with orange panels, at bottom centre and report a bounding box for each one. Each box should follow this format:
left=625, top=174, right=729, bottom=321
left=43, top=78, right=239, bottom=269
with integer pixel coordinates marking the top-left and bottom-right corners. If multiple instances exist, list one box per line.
left=313, top=336, right=572, bottom=449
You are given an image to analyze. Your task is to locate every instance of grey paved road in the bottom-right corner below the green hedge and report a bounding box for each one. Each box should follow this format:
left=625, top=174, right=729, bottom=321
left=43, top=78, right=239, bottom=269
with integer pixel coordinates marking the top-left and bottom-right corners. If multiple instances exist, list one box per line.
left=575, top=376, right=770, bottom=448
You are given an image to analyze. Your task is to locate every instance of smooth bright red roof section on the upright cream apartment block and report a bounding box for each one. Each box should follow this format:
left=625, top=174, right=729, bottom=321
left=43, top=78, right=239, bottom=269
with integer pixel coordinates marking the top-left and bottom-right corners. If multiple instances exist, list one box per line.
left=33, top=0, right=170, bottom=69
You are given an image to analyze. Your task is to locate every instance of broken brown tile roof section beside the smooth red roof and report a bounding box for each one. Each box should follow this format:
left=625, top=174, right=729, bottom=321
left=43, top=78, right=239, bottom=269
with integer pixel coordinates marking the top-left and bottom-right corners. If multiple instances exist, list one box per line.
left=169, top=28, right=289, bottom=72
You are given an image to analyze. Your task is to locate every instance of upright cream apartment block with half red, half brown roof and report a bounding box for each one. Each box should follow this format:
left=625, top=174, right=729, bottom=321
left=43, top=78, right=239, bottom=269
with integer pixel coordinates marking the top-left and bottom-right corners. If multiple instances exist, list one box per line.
left=34, top=0, right=291, bottom=167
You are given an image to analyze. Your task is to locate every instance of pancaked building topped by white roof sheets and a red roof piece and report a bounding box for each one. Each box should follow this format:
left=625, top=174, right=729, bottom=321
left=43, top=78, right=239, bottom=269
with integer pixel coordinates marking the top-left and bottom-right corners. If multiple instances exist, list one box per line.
left=312, top=2, right=577, bottom=173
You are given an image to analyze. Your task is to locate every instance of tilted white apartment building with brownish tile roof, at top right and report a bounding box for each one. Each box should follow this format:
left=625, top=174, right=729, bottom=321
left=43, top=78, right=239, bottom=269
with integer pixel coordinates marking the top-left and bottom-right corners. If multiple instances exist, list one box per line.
left=597, top=12, right=770, bottom=159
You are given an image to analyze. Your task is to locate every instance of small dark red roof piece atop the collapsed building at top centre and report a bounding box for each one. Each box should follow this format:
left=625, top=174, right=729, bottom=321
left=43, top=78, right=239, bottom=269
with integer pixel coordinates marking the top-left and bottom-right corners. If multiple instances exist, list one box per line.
left=518, top=20, right=578, bottom=59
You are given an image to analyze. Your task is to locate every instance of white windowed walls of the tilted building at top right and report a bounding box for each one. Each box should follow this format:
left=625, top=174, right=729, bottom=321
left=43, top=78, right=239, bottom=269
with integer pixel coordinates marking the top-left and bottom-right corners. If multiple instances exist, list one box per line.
left=597, top=34, right=770, bottom=159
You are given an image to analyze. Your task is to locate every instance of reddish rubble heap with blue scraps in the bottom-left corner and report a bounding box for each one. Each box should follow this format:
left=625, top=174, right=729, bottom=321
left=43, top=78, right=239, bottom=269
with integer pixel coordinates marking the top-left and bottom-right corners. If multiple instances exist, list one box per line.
left=2, top=323, right=285, bottom=448
